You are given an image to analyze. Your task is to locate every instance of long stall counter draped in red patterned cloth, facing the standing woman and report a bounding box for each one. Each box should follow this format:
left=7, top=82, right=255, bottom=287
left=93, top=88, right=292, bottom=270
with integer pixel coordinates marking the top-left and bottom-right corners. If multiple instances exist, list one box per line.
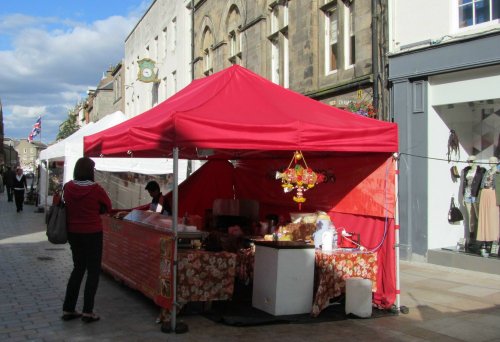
left=102, top=212, right=236, bottom=318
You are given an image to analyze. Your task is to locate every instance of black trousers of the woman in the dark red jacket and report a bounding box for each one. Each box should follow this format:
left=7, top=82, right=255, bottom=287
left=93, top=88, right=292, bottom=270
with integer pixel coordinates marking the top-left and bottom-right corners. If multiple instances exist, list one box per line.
left=63, top=232, right=102, bottom=314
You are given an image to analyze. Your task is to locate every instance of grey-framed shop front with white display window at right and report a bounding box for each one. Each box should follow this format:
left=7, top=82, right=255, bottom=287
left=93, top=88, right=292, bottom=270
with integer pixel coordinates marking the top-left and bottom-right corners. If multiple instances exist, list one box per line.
left=390, top=34, right=500, bottom=273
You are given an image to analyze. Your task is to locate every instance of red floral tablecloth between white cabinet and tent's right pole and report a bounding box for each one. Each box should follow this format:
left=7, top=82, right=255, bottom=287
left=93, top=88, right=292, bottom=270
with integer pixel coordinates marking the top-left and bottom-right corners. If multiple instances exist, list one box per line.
left=311, top=251, right=378, bottom=317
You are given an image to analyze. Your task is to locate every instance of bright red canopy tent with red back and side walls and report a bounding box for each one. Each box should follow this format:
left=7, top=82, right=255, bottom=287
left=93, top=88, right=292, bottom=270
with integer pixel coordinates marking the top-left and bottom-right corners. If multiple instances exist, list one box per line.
left=84, top=65, right=398, bottom=318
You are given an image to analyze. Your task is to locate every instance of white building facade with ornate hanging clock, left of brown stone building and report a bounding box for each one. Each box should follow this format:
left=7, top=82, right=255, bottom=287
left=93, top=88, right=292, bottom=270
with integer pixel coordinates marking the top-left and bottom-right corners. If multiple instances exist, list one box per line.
left=123, top=0, right=192, bottom=117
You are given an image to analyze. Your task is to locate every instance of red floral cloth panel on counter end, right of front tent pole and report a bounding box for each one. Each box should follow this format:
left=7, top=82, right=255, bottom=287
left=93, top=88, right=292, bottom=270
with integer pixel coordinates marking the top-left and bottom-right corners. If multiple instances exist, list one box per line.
left=177, top=250, right=236, bottom=303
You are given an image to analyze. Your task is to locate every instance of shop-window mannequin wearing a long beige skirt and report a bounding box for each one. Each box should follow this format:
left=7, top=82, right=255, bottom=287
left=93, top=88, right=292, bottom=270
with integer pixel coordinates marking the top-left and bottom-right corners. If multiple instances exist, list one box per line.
left=477, top=157, right=500, bottom=241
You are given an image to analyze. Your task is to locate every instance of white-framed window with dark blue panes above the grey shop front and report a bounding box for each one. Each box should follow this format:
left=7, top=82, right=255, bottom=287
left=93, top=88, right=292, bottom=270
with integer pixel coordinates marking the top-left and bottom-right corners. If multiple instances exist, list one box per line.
left=458, top=0, right=500, bottom=28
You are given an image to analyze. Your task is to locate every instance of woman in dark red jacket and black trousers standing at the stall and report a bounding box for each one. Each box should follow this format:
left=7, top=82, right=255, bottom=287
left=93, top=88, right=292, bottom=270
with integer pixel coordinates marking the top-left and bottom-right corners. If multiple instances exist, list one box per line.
left=62, top=157, right=111, bottom=323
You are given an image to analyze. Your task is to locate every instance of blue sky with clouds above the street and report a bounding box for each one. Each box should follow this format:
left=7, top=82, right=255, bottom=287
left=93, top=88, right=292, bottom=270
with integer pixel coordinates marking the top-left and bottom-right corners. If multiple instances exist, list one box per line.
left=0, top=0, right=152, bottom=144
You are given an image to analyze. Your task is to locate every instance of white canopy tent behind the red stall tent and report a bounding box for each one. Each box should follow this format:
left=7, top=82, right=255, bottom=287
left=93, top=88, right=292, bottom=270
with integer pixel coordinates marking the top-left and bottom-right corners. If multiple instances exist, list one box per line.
left=39, top=111, right=187, bottom=206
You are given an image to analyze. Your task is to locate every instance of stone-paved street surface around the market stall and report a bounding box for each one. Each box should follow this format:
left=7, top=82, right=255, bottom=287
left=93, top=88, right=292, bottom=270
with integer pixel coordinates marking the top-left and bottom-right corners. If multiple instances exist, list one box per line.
left=0, top=193, right=500, bottom=342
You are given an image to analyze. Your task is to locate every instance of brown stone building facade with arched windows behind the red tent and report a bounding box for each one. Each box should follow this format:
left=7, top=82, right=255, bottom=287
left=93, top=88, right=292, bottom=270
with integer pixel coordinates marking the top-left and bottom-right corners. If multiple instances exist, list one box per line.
left=193, top=0, right=387, bottom=119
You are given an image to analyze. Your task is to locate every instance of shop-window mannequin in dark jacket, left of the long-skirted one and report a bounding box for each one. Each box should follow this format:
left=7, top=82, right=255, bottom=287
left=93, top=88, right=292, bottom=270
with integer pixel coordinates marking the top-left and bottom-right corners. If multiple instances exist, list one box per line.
left=462, top=156, right=486, bottom=240
